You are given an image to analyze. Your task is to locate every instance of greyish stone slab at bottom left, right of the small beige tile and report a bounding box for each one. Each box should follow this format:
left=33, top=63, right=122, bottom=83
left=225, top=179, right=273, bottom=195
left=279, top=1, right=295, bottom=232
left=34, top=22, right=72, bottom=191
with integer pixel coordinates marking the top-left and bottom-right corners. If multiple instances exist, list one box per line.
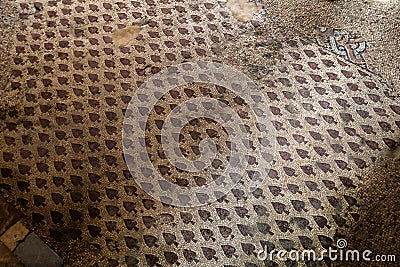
left=14, top=233, right=63, bottom=267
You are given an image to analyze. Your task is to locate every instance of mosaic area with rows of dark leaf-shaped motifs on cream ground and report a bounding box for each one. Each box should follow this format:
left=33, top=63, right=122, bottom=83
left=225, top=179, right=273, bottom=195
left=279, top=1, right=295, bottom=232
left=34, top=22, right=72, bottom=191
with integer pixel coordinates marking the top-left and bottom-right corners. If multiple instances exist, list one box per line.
left=0, top=0, right=400, bottom=267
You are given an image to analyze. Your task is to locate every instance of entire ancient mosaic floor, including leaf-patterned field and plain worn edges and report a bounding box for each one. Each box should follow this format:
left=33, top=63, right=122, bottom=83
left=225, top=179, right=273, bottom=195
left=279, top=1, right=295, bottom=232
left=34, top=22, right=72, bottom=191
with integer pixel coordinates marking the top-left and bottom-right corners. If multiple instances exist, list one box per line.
left=0, top=0, right=400, bottom=267
